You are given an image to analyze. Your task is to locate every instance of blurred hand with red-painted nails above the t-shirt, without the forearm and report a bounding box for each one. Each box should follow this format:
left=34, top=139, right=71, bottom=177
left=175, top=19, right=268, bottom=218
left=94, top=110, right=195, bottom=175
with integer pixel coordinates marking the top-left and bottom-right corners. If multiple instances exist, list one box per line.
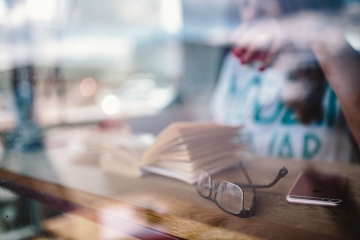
left=232, top=19, right=289, bottom=71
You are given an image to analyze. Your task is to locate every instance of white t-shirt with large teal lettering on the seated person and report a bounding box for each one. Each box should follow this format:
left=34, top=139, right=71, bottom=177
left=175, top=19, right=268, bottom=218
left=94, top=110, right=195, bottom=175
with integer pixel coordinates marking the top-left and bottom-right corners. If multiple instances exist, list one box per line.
left=211, top=54, right=354, bottom=162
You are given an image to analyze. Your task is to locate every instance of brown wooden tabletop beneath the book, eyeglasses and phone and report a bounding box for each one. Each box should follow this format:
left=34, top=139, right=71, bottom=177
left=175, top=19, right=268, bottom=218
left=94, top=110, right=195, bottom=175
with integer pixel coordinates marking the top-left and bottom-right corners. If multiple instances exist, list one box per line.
left=0, top=149, right=360, bottom=239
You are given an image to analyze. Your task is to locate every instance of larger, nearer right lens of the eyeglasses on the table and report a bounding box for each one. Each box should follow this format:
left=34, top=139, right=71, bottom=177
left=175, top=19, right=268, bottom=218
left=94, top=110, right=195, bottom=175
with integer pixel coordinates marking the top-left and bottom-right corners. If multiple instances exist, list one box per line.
left=215, top=181, right=243, bottom=214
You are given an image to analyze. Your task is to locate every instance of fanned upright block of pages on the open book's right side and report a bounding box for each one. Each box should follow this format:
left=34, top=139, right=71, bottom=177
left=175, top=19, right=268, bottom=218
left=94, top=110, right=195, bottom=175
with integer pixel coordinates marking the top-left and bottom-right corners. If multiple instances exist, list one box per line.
left=140, top=122, right=241, bottom=183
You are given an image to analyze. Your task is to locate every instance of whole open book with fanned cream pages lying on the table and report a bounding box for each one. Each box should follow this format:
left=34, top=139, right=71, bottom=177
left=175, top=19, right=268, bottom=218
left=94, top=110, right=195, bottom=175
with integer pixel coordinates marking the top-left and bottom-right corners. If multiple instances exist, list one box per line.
left=100, top=122, right=241, bottom=184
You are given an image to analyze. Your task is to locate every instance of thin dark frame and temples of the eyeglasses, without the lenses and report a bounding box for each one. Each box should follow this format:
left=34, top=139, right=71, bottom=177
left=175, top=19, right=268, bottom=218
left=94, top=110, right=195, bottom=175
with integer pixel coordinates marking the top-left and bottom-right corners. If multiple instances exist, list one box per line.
left=196, top=162, right=288, bottom=218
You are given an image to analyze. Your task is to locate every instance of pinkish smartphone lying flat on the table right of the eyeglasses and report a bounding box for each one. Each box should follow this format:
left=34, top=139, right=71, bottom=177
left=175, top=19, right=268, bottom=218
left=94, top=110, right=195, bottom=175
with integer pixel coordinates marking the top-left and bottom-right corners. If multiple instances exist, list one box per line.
left=289, top=172, right=346, bottom=201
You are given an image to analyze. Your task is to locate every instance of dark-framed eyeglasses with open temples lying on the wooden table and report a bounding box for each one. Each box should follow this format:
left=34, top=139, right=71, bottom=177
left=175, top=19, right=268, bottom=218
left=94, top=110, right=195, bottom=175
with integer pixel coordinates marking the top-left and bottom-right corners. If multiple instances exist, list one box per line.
left=197, top=162, right=288, bottom=218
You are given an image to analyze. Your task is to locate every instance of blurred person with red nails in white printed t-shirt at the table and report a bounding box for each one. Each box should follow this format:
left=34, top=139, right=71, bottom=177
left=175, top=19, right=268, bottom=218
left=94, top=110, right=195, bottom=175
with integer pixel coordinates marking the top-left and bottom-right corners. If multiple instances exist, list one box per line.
left=211, top=0, right=360, bottom=162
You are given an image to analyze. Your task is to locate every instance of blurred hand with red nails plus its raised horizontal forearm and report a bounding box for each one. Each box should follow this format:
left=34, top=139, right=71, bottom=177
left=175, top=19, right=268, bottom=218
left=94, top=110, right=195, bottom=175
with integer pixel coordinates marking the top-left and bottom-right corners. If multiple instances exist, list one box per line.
left=231, top=12, right=341, bottom=70
